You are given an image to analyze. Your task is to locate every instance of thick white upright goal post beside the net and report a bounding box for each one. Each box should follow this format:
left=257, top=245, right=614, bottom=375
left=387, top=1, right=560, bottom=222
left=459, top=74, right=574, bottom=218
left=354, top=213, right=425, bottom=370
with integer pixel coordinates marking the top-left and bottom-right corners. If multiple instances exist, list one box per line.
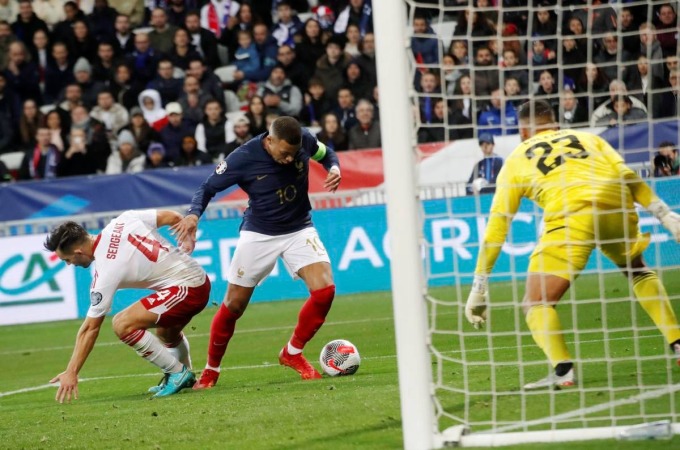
left=373, top=0, right=436, bottom=450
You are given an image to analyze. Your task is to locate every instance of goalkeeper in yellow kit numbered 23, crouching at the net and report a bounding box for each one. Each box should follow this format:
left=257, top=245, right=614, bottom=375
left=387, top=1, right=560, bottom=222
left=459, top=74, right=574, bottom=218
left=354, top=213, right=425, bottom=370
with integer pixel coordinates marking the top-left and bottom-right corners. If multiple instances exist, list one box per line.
left=465, top=100, right=680, bottom=389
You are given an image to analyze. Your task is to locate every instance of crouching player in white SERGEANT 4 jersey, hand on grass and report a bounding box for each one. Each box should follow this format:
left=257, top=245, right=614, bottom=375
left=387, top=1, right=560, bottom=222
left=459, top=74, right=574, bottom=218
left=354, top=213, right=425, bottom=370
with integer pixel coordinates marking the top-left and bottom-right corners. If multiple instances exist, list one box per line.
left=45, top=210, right=210, bottom=403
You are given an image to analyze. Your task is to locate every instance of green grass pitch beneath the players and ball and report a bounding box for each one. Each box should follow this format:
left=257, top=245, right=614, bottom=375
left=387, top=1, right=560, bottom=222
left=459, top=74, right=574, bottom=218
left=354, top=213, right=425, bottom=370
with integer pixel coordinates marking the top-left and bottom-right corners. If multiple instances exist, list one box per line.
left=0, top=271, right=680, bottom=450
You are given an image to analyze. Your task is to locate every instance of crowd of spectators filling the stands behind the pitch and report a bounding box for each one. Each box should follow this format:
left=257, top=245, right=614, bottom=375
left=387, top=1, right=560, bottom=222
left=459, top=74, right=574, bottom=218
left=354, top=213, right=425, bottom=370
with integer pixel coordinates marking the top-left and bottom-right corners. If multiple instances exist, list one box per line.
left=0, top=0, right=680, bottom=180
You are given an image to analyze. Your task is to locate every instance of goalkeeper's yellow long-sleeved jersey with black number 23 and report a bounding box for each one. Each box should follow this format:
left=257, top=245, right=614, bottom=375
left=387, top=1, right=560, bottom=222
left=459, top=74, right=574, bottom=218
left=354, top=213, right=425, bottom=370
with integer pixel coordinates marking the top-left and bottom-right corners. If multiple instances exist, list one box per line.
left=476, top=130, right=656, bottom=273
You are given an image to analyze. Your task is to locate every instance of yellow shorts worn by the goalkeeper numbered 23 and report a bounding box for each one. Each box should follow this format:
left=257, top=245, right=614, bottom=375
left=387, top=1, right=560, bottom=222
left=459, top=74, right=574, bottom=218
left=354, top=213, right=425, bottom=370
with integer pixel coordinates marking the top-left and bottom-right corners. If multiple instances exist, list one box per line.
left=529, top=210, right=649, bottom=280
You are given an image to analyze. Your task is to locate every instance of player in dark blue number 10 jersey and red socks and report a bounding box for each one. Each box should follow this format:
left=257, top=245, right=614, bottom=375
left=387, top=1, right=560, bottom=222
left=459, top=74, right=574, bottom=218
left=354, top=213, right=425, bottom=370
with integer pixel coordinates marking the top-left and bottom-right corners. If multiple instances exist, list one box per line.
left=173, top=117, right=341, bottom=389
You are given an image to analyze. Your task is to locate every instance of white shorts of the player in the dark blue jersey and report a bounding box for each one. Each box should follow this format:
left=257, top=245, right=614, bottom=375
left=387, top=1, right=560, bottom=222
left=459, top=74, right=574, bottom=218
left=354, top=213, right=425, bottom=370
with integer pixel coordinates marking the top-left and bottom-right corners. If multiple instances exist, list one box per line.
left=227, top=227, right=331, bottom=287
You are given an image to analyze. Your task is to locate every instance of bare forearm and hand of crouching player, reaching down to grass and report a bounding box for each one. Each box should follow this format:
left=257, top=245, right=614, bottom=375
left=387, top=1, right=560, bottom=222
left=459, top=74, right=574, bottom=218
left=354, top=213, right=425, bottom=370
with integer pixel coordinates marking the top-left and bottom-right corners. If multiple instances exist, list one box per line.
left=50, top=316, right=106, bottom=403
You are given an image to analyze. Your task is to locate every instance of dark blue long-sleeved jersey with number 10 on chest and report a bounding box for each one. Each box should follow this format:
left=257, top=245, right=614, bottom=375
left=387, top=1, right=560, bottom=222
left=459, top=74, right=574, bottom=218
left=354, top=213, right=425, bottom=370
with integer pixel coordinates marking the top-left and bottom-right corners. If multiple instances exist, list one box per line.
left=188, top=128, right=339, bottom=235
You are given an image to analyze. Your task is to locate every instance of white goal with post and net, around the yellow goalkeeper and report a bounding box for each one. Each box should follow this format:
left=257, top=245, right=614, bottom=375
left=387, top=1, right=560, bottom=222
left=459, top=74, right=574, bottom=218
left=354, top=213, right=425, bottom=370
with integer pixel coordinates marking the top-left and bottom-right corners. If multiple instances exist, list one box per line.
left=373, top=0, right=680, bottom=448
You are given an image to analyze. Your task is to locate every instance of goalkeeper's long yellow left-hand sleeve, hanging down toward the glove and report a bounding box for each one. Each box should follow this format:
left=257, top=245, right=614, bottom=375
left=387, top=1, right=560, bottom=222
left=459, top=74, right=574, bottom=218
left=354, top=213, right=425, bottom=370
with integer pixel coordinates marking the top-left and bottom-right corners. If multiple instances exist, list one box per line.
left=475, top=157, right=525, bottom=274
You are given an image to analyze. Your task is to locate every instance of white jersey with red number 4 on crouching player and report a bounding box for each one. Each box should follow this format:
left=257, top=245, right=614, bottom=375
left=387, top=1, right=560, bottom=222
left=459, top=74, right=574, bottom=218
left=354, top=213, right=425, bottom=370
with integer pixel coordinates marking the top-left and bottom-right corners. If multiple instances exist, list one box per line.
left=87, top=209, right=206, bottom=317
